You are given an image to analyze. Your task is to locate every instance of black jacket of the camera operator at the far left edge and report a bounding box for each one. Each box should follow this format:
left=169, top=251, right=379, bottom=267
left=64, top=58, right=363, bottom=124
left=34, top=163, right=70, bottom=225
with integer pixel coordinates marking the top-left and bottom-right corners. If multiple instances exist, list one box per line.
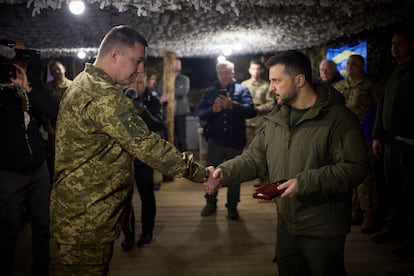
left=0, top=84, right=45, bottom=172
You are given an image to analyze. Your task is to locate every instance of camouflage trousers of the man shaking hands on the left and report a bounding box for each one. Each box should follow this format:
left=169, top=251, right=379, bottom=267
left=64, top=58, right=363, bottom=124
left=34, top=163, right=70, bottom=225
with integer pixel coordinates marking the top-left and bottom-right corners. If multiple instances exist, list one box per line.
left=58, top=242, right=114, bottom=276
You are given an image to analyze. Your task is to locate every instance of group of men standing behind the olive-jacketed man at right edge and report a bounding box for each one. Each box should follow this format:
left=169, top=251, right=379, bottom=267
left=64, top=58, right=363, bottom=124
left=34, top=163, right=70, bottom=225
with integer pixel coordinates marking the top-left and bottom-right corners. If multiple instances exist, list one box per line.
left=320, top=29, right=414, bottom=258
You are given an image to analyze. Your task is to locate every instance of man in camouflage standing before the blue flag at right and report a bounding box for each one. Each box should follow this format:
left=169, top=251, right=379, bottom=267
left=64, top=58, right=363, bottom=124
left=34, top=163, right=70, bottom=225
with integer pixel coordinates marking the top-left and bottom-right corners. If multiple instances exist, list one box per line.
left=334, top=55, right=379, bottom=233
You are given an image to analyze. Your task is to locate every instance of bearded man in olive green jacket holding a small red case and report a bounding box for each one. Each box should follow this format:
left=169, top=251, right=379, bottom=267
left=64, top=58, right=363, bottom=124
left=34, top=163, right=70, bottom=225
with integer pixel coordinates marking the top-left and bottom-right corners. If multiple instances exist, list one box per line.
left=204, top=51, right=367, bottom=276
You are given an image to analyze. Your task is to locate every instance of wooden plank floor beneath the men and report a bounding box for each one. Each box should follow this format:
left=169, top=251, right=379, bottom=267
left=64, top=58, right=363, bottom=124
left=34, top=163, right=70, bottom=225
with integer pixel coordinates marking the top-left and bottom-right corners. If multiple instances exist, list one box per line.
left=14, top=176, right=414, bottom=276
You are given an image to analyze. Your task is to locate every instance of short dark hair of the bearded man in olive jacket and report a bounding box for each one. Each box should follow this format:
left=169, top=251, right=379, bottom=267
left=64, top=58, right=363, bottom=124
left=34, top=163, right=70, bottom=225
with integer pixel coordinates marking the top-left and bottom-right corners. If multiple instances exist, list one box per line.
left=266, top=50, right=312, bottom=83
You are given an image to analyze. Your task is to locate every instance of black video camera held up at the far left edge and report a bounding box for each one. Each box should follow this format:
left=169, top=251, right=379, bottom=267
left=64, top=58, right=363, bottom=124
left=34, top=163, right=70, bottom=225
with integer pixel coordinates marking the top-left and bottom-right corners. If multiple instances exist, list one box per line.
left=0, top=39, right=40, bottom=83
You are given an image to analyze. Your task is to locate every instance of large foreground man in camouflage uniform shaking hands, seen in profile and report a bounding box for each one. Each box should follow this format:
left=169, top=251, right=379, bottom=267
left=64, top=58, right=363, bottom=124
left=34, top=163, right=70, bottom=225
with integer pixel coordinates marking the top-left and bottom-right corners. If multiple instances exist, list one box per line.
left=51, top=26, right=208, bottom=275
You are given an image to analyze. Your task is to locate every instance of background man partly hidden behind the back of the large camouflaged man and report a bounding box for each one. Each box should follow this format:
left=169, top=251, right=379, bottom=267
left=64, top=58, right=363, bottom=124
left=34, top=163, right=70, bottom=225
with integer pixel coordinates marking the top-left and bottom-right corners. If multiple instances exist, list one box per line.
left=43, top=60, right=72, bottom=179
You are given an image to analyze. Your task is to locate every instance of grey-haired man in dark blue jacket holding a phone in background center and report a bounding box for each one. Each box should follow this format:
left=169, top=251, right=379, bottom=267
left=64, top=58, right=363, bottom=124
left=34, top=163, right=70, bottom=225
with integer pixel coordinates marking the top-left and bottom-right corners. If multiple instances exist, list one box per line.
left=198, top=61, right=256, bottom=220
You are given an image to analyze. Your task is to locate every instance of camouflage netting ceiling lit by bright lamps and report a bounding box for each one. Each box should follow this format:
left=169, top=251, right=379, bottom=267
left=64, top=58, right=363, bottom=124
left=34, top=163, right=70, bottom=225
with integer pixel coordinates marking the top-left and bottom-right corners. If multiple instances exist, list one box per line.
left=0, top=0, right=414, bottom=57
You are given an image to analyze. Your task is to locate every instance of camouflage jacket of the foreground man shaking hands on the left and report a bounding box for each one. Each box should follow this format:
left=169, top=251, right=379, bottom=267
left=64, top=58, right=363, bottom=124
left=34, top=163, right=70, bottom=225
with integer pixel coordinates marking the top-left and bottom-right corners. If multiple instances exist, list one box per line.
left=51, top=64, right=206, bottom=245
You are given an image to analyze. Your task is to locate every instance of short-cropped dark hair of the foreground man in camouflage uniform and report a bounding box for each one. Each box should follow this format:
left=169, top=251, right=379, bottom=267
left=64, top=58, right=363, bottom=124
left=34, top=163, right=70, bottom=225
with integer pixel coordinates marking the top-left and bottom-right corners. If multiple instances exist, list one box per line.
left=98, top=25, right=148, bottom=57
